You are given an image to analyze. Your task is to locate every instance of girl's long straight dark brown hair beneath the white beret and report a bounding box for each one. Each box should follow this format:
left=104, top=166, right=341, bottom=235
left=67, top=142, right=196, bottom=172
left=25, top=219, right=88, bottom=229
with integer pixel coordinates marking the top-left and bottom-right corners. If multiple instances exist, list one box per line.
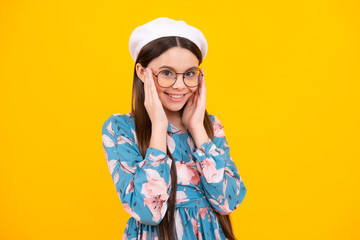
left=131, top=36, right=236, bottom=240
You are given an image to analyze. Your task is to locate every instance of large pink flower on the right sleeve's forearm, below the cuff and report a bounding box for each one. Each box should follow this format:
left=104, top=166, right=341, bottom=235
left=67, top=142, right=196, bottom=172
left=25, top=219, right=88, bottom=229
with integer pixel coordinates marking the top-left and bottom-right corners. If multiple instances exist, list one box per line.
left=197, top=158, right=224, bottom=183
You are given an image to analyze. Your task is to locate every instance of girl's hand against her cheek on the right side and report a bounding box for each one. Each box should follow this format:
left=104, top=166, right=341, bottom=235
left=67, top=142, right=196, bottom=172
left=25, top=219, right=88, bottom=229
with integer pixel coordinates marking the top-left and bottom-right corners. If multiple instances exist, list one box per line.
left=182, top=68, right=206, bottom=132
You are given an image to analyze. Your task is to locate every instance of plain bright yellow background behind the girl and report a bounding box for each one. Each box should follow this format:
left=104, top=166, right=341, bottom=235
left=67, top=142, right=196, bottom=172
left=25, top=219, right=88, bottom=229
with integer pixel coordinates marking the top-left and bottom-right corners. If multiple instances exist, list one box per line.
left=0, top=0, right=360, bottom=240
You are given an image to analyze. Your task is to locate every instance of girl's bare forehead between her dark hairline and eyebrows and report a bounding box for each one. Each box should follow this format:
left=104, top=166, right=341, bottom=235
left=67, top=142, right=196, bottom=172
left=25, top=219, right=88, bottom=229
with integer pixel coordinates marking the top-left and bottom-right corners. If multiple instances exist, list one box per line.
left=149, top=47, right=199, bottom=70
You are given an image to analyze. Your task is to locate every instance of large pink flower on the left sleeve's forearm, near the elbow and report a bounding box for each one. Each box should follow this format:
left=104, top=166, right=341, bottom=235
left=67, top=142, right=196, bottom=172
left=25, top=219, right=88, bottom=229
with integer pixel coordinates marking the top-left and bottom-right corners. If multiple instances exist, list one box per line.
left=141, top=169, right=169, bottom=222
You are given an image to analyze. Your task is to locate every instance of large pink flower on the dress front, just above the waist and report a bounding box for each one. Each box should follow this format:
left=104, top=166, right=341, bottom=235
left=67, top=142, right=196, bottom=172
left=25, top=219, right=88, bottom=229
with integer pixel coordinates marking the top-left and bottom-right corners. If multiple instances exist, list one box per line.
left=175, top=160, right=200, bottom=186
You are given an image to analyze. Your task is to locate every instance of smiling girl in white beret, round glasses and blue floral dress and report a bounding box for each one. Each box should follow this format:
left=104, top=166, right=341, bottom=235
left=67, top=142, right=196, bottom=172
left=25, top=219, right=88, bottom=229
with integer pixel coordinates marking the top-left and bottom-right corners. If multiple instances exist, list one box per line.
left=102, top=18, right=246, bottom=240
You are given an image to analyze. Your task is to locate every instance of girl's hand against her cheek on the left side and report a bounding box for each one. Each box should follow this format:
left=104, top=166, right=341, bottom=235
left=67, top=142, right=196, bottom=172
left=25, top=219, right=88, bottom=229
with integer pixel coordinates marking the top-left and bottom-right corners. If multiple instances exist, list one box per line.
left=144, top=68, right=168, bottom=129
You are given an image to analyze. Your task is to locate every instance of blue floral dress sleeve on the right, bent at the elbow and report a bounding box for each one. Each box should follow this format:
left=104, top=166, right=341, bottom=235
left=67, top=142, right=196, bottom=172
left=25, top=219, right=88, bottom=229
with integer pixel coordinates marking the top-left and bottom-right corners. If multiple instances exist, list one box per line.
left=194, top=115, right=246, bottom=215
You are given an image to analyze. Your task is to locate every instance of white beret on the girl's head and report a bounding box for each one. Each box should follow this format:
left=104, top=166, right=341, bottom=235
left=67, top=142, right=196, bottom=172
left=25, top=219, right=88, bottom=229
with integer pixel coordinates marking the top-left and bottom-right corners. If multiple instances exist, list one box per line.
left=129, top=17, right=207, bottom=61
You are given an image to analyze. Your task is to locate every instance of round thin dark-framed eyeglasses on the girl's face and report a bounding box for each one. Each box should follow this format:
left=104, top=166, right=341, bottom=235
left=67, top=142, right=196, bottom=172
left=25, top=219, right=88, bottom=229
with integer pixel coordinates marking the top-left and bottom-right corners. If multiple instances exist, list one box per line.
left=153, top=68, right=204, bottom=88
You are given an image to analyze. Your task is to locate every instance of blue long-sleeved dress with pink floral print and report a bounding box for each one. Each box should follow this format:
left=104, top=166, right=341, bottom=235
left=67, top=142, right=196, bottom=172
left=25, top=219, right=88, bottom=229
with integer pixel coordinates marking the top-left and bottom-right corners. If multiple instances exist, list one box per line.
left=102, top=113, right=246, bottom=240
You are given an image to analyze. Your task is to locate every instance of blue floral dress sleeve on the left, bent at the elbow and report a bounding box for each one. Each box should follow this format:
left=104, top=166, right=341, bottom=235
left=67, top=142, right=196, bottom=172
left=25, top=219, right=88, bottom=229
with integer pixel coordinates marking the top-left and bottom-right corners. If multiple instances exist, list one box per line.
left=102, top=114, right=171, bottom=225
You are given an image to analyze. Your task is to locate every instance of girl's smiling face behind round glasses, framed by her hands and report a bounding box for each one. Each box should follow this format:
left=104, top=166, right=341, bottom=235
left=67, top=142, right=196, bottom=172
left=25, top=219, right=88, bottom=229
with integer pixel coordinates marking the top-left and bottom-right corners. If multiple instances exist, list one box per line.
left=137, top=47, right=199, bottom=112
